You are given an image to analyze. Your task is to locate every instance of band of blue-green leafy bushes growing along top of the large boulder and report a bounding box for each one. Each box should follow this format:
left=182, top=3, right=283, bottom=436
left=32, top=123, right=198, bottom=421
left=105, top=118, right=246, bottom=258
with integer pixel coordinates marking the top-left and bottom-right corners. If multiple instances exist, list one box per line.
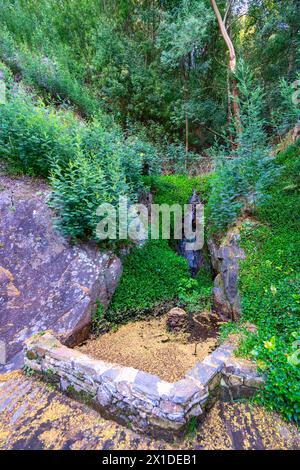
left=0, top=89, right=159, bottom=240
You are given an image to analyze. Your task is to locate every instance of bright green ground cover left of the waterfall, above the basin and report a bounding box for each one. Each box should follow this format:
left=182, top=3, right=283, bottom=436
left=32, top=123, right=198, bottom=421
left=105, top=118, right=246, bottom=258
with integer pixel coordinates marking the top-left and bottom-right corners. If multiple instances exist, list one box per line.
left=107, top=175, right=212, bottom=323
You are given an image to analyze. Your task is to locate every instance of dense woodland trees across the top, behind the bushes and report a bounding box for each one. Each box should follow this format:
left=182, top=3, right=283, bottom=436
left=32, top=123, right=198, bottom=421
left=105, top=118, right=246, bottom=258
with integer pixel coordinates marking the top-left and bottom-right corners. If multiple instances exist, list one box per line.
left=0, top=0, right=300, bottom=151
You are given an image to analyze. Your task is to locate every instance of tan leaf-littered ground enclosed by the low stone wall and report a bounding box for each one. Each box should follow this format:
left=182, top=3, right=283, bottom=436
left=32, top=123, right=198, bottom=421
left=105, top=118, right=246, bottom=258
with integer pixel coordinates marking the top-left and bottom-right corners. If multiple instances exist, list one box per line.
left=76, top=316, right=217, bottom=382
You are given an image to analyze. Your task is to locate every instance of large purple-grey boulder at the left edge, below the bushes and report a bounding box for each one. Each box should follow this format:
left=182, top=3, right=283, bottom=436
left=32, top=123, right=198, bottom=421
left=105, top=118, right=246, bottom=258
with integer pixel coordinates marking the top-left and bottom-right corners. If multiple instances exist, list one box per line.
left=0, top=176, right=122, bottom=372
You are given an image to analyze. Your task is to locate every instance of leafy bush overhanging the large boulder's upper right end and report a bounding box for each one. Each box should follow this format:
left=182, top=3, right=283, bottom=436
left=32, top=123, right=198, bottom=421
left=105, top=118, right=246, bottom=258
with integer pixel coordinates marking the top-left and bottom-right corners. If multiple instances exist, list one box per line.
left=50, top=149, right=127, bottom=240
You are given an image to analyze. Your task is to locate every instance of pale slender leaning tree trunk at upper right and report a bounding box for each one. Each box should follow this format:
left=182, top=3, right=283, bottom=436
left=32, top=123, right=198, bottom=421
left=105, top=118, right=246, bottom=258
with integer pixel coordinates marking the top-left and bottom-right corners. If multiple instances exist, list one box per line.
left=210, top=0, right=241, bottom=137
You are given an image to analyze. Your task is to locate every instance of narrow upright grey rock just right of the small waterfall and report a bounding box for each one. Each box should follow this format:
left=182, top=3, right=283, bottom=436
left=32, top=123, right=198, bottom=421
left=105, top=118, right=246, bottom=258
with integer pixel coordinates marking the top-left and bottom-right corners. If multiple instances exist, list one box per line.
left=208, top=230, right=245, bottom=321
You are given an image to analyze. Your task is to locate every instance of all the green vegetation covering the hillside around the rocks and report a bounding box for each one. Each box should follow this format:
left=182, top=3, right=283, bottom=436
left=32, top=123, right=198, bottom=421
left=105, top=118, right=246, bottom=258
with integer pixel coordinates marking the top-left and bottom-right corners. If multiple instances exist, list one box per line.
left=0, top=0, right=300, bottom=423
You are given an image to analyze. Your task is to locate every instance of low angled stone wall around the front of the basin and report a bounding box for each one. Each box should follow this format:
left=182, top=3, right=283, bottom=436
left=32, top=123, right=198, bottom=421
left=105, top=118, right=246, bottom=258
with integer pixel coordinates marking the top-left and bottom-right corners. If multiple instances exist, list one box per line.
left=24, top=332, right=263, bottom=439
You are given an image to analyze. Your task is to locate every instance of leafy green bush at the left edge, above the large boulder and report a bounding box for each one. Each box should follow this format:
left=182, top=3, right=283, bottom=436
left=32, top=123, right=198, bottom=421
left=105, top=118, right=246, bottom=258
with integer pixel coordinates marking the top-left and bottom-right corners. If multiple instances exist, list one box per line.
left=0, top=94, right=76, bottom=176
